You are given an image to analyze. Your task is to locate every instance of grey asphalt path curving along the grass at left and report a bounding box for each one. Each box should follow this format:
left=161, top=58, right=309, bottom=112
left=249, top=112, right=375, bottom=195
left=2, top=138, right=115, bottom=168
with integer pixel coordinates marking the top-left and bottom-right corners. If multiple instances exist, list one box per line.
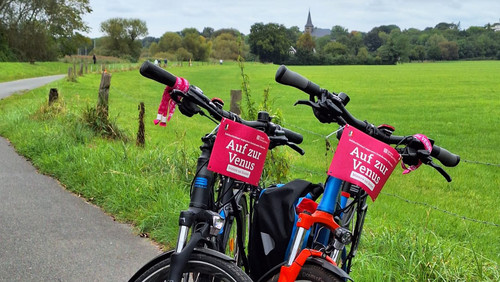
left=0, top=75, right=160, bottom=281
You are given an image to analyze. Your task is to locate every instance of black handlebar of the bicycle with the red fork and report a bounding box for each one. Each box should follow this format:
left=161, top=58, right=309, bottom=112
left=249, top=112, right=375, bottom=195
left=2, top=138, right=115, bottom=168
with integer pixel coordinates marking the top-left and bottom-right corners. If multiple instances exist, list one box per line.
left=275, top=65, right=460, bottom=167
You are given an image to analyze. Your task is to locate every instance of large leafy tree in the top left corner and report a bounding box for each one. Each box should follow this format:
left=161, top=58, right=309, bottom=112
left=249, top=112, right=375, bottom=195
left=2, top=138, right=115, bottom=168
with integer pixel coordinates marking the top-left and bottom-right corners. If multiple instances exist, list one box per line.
left=0, top=0, right=92, bottom=61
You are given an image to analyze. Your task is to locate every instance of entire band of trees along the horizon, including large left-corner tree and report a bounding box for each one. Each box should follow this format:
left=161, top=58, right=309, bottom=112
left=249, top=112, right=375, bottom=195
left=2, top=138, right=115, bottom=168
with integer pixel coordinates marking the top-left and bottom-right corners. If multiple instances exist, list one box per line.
left=0, top=0, right=500, bottom=65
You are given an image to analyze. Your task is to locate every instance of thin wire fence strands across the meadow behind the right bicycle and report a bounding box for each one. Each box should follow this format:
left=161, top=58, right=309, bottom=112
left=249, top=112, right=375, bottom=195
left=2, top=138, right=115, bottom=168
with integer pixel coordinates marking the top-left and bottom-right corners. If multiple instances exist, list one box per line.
left=283, top=123, right=500, bottom=227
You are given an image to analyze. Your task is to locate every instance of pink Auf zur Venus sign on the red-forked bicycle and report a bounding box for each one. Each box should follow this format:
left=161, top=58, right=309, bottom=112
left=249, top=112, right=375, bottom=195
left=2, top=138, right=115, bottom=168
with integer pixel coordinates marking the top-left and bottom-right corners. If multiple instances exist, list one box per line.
left=328, top=125, right=401, bottom=201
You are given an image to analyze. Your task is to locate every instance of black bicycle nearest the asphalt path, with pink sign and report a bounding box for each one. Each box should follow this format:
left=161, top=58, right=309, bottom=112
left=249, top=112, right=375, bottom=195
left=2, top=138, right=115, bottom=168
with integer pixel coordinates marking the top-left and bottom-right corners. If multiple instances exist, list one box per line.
left=130, top=62, right=304, bottom=281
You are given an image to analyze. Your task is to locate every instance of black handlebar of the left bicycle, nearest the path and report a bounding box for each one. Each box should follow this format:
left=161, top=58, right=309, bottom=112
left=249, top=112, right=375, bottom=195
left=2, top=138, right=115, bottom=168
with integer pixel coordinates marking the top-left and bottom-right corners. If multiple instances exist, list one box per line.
left=139, top=61, right=303, bottom=147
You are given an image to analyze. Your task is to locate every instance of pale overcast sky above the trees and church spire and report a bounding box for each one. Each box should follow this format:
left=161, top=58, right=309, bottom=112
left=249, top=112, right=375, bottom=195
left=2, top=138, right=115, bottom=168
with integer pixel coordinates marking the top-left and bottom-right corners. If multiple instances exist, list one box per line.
left=83, top=0, right=500, bottom=38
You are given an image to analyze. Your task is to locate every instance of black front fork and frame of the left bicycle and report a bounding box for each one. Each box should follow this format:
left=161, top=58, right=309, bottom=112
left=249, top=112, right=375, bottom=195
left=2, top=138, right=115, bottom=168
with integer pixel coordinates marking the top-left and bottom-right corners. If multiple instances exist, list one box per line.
left=169, top=126, right=264, bottom=281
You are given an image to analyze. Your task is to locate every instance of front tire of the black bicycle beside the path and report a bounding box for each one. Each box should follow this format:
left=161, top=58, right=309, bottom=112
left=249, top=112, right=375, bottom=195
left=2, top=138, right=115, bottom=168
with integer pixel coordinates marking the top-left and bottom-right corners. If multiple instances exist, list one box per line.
left=131, top=253, right=252, bottom=282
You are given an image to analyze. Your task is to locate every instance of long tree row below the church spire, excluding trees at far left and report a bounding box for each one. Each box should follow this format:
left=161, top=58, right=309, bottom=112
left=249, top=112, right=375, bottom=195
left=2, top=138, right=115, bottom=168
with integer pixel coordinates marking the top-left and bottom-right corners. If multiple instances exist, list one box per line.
left=143, top=23, right=500, bottom=65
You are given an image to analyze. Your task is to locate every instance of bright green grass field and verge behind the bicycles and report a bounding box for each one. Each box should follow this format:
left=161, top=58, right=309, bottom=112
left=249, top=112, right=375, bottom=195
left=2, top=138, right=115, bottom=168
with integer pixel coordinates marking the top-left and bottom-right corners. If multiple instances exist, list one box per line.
left=0, top=61, right=500, bottom=281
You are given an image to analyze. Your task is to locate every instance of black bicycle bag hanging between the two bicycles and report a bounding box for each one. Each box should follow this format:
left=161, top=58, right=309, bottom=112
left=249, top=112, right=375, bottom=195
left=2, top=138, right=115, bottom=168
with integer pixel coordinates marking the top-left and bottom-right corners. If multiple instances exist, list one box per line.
left=248, top=180, right=318, bottom=281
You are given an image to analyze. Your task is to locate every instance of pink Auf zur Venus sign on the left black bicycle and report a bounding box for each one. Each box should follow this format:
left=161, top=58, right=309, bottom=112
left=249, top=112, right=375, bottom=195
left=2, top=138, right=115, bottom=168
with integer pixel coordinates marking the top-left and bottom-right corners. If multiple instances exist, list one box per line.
left=208, top=119, right=269, bottom=185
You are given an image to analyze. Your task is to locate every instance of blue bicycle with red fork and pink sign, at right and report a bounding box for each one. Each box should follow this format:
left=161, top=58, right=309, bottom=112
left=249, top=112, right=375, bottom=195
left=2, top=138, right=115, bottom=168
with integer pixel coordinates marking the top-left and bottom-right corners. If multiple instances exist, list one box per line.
left=254, top=65, right=460, bottom=282
